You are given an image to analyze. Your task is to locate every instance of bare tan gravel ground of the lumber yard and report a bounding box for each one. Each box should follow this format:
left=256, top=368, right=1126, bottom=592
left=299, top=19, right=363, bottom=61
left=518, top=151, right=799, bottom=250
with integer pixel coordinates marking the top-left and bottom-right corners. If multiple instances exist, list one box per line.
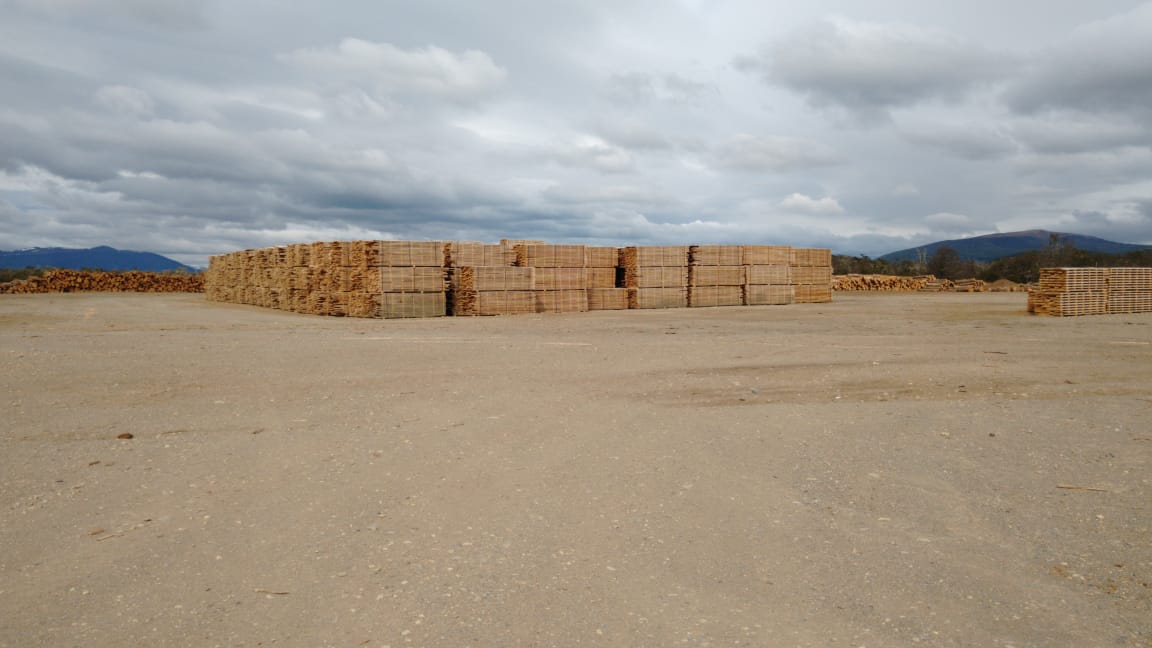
left=0, top=294, right=1152, bottom=648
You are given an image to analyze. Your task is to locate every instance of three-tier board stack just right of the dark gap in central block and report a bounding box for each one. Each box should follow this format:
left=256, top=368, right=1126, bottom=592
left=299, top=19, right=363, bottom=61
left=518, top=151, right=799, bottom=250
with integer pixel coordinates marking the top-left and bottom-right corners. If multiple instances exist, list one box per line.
left=620, top=246, right=688, bottom=308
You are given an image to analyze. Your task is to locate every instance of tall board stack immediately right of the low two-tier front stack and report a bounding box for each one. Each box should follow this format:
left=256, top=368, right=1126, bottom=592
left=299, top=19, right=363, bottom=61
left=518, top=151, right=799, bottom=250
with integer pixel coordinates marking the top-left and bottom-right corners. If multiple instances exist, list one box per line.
left=515, top=243, right=588, bottom=312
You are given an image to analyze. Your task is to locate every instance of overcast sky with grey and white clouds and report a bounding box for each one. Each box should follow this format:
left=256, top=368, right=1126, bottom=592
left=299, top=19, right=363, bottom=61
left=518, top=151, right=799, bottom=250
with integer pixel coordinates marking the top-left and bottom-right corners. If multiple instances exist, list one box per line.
left=0, top=0, right=1152, bottom=265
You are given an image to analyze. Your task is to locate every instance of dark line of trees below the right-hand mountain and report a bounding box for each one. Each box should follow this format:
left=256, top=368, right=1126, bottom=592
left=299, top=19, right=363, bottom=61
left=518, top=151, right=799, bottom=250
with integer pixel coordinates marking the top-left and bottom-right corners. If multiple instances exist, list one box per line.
left=832, top=234, right=1152, bottom=284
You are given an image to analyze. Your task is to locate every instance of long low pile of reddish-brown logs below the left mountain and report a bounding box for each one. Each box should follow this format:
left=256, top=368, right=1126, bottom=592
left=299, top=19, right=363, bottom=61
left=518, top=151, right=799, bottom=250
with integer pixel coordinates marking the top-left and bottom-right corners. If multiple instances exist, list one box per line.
left=0, top=270, right=204, bottom=294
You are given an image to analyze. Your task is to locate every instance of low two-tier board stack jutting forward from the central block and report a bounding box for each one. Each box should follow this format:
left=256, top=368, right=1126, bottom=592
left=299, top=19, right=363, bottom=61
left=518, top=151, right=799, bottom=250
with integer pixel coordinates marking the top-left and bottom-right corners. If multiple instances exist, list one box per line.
left=452, top=265, right=536, bottom=316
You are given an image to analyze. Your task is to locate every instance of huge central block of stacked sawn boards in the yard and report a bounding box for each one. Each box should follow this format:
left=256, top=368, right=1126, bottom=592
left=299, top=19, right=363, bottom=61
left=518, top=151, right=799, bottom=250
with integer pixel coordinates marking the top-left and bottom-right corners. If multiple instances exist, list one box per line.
left=205, top=240, right=832, bottom=318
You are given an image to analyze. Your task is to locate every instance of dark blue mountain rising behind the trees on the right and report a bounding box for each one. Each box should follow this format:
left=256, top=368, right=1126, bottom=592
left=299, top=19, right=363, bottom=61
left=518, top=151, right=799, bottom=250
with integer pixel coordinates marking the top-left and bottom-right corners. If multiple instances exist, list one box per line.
left=880, top=229, right=1152, bottom=263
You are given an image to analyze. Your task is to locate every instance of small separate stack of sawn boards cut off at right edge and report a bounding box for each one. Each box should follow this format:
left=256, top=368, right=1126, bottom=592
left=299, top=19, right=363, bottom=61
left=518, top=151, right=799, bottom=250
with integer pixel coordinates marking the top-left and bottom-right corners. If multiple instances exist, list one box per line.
left=1028, top=268, right=1152, bottom=317
